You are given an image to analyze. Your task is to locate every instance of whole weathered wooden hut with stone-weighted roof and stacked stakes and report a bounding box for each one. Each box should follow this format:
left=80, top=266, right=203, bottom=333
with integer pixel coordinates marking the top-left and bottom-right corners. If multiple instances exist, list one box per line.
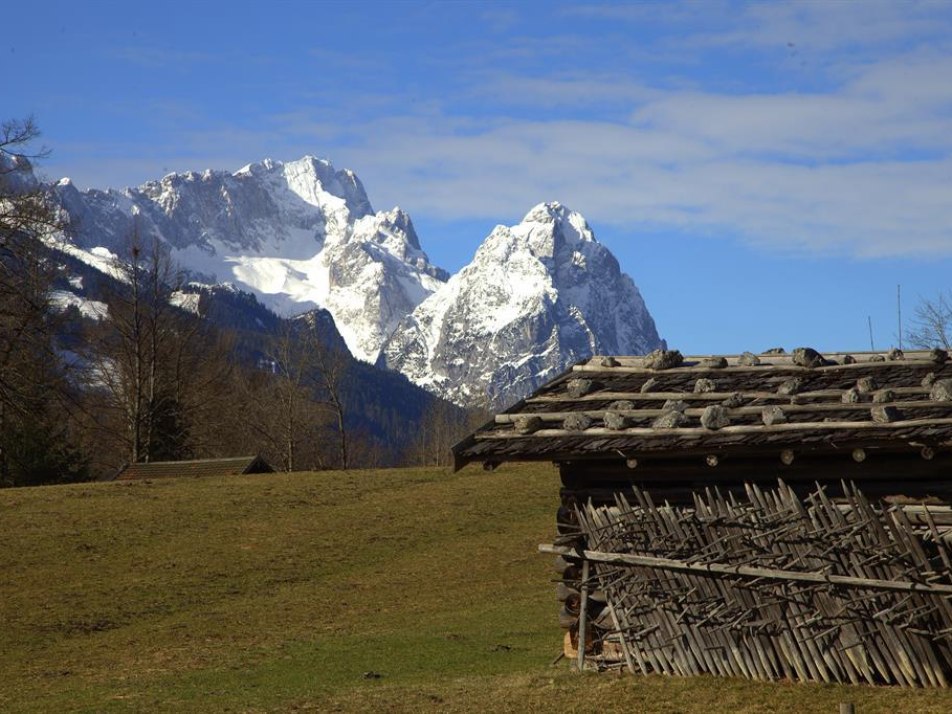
left=453, top=348, right=952, bottom=687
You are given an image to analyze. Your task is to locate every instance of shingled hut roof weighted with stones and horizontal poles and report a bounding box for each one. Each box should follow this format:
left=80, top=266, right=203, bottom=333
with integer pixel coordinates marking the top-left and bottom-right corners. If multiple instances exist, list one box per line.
left=453, top=348, right=952, bottom=469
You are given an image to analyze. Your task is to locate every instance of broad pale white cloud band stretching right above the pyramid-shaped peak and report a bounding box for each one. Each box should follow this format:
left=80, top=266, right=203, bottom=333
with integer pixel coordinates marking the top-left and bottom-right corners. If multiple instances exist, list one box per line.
left=314, top=39, right=952, bottom=256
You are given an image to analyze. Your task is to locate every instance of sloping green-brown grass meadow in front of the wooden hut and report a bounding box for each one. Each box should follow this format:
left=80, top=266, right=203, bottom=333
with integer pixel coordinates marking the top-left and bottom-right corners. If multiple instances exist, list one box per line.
left=0, top=466, right=952, bottom=713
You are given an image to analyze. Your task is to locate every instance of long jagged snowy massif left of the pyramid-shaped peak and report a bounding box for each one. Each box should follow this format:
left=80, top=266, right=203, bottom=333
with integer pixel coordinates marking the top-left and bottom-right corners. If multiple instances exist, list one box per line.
left=53, top=156, right=448, bottom=362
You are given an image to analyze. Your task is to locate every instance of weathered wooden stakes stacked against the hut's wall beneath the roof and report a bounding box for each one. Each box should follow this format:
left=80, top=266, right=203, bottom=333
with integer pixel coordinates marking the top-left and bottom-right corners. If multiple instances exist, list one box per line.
left=548, top=482, right=952, bottom=687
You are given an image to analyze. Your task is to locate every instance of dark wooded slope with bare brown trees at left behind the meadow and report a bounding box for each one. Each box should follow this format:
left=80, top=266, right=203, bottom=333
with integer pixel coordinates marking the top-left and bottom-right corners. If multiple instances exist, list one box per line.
left=0, top=120, right=482, bottom=486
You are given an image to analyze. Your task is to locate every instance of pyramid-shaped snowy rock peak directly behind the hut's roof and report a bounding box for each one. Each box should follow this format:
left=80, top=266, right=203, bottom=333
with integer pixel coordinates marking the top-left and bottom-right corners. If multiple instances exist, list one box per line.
left=380, top=203, right=664, bottom=409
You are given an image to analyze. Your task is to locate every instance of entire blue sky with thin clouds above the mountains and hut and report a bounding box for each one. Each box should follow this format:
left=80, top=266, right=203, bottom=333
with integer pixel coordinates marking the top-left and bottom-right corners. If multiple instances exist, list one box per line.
left=7, top=0, right=952, bottom=354
